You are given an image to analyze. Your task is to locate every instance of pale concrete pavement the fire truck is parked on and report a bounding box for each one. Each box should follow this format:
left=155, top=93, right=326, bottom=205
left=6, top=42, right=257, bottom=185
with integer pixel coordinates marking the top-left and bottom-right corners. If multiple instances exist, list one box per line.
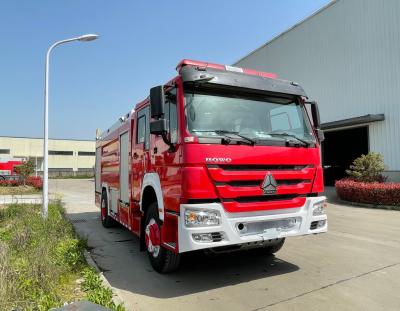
left=50, top=180, right=400, bottom=311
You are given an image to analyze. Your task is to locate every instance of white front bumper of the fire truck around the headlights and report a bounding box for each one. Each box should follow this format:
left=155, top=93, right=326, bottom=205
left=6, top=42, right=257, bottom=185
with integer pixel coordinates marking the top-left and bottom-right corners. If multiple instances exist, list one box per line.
left=178, top=196, right=328, bottom=253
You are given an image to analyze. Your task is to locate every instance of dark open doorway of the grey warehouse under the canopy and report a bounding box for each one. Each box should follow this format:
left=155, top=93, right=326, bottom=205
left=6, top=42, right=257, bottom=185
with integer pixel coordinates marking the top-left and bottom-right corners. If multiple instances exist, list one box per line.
left=322, top=126, right=369, bottom=186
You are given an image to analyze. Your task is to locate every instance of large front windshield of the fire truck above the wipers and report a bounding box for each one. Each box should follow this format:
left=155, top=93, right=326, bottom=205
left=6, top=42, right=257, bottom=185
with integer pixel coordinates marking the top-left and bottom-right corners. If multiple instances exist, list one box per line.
left=185, top=91, right=315, bottom=143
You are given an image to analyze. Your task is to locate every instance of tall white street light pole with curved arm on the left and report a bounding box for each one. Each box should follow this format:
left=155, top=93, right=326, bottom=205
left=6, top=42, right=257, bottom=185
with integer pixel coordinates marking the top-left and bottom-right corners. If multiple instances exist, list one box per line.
left=42, top=34, right=99, bottom=218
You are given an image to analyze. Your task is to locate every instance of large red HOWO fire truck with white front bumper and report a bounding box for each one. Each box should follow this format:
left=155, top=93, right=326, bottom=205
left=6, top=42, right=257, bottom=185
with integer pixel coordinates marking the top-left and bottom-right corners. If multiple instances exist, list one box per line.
left=95, top=60, right=327, bottom=273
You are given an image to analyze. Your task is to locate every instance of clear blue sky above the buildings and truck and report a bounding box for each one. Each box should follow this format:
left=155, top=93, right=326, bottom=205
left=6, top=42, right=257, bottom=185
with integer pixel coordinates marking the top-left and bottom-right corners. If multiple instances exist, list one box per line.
left=0, top=0, right=329, bottom=139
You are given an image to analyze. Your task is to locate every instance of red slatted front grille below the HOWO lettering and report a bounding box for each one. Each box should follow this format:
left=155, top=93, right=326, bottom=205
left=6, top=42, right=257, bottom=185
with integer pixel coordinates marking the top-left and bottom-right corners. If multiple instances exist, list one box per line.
left=207, top=164, right=315, bottom=212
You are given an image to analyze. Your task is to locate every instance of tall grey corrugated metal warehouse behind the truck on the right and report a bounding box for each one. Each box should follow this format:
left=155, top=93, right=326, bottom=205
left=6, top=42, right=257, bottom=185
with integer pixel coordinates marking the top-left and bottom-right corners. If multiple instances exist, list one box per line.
left=235, top=0, right=400, bottom=184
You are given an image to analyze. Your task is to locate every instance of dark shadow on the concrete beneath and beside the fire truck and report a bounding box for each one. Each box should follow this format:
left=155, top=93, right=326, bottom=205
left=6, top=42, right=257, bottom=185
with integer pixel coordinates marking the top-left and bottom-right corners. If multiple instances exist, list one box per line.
left=67, top=212, right=299, bottom=298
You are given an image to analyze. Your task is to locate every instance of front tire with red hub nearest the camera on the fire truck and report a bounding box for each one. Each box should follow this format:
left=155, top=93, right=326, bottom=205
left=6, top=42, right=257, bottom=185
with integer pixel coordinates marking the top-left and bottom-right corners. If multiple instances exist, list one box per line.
left=144, top=202, right=181, bottom=273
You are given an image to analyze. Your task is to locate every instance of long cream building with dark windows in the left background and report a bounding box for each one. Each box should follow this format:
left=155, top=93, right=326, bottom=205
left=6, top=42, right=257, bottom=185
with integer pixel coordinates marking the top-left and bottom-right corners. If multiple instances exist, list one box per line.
left=0, top=137, right=96, bottom=176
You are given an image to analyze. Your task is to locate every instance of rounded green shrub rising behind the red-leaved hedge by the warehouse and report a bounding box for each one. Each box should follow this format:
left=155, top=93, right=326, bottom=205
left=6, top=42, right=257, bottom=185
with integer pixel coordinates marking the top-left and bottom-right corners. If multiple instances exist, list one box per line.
left=346, top=152, right=386, bottom=182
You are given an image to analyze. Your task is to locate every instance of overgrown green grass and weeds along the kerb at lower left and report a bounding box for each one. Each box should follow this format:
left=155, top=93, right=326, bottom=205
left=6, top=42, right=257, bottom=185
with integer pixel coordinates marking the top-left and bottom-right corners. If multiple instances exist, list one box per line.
left=0, top=202, right=123, bottom=311
